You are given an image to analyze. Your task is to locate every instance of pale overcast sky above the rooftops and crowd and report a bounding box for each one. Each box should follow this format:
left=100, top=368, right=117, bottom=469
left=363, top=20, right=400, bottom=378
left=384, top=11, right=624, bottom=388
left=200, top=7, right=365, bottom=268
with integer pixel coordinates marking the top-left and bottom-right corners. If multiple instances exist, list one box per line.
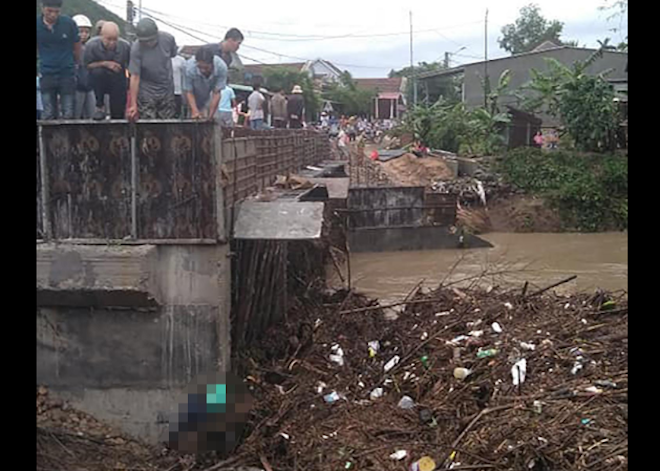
left=91, top=0, right=627, bottom=78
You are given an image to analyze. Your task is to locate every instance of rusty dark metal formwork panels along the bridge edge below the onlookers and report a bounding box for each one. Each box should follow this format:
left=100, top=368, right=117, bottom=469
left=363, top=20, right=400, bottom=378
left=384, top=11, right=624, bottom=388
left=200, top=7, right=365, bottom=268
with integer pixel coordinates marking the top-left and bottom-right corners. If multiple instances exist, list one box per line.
left=37, top=121, right=330, bottom=243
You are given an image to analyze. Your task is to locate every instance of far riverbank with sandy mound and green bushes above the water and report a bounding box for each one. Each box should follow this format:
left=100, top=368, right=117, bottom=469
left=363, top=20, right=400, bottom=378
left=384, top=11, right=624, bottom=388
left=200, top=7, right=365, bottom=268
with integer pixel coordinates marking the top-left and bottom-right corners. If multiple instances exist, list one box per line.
left=360, top=145, right=628, bottom=234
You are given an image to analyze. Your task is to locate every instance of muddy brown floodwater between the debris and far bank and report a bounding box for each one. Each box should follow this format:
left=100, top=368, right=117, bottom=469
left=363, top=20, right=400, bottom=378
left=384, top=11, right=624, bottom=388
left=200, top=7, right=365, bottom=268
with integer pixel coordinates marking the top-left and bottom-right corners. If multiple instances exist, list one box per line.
left=330, top=232, right=628, bottom=300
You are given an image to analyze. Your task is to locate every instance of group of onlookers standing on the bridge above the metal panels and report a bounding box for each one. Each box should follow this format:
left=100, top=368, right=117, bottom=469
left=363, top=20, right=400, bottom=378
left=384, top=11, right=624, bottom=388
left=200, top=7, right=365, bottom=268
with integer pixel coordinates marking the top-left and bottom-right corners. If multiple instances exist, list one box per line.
left=37, top=0, right=305, bottom=129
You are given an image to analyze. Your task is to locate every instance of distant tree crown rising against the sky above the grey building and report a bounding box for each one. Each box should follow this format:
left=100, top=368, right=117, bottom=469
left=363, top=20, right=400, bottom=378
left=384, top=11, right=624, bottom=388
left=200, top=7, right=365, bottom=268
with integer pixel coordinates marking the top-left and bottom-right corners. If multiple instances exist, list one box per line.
left=498, top=4, right=564, bottom=54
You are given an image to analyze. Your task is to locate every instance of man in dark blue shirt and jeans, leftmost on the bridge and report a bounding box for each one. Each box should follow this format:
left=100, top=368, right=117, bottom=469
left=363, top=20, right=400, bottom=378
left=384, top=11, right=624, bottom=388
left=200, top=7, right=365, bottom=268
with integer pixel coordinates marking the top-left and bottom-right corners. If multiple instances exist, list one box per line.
left=37, top=0, right=82, bottom=119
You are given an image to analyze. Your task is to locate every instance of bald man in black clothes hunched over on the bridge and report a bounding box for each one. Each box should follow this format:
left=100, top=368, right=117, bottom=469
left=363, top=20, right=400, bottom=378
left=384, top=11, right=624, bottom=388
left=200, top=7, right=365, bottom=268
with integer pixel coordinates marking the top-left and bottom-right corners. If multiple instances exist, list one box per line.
left=83, top=21, right=131, bottom=120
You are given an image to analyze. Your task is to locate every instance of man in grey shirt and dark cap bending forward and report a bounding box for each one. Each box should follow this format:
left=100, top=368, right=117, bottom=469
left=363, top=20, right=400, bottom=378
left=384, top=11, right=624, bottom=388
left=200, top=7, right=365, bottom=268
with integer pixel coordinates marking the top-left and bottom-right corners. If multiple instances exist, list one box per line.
left=127, top=18, right=177, bottom=120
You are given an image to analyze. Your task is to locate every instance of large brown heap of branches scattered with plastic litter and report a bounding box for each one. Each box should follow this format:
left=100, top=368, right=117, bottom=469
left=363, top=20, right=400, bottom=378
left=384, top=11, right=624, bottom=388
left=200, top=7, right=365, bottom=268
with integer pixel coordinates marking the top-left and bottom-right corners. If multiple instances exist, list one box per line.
left=238, top=287, right=628, bottom=471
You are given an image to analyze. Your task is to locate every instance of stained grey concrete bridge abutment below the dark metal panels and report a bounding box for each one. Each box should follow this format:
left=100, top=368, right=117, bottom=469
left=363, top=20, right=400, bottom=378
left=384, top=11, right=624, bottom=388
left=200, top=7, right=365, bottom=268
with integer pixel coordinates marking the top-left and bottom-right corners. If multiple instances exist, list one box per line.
left=37, top=244, right=230, bottom=443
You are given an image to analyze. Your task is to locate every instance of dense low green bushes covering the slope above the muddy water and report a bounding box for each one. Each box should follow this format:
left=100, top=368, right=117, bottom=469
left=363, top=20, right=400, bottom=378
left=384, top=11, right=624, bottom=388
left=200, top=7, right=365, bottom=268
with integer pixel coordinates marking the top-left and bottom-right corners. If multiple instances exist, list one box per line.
left=497, top=148, right=628, bottom=232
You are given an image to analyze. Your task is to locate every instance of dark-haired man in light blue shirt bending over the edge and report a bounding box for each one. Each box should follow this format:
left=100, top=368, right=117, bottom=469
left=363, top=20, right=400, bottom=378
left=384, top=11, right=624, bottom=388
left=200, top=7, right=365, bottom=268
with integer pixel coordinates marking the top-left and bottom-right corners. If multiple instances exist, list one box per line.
left=183, top=46, right=227, bottom=119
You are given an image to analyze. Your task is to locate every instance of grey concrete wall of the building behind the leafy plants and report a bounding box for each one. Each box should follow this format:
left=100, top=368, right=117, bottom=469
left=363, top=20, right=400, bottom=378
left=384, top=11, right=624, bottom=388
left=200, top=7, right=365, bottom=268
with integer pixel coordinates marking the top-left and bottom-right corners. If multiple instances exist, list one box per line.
left=464, top=48, right=628, bottom=125
